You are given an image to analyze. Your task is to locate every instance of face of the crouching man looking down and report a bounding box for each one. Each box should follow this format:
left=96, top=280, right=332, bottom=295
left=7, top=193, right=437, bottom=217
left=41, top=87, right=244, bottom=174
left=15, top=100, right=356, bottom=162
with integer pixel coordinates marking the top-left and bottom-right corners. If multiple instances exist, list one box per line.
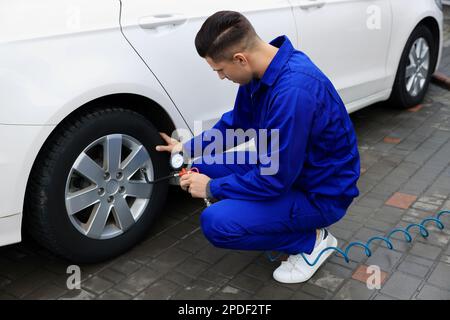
left=206, top=53, right=253, bottom=84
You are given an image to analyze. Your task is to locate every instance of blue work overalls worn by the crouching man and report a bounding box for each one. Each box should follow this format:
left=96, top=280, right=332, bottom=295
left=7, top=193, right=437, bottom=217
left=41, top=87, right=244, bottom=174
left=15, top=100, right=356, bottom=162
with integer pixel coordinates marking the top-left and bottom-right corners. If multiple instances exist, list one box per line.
left=183, top=36, right=360, bottom=254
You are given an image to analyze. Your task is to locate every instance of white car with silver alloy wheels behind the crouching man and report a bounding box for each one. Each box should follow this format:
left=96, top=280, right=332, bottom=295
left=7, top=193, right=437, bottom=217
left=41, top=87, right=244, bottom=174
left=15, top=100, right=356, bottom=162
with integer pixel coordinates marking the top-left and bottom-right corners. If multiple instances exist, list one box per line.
left=0, top=0, right=443, bottom=262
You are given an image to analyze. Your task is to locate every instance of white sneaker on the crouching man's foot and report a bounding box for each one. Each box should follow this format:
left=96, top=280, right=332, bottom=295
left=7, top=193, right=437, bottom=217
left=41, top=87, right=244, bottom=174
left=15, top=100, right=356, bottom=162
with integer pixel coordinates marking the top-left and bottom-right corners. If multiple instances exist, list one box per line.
left=273, top=229, right=337, bottom=283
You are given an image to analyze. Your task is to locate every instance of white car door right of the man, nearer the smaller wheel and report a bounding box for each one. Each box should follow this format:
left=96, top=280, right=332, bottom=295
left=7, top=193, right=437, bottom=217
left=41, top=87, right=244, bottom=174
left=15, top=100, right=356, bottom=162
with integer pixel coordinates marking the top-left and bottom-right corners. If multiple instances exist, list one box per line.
left=290, top=0, right=391, bottom=107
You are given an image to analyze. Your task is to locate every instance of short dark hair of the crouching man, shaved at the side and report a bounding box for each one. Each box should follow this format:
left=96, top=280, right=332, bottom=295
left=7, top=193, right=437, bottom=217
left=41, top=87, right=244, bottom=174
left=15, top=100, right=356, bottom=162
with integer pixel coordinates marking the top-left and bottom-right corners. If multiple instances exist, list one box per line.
left=195, top=11, right=258, bottom=62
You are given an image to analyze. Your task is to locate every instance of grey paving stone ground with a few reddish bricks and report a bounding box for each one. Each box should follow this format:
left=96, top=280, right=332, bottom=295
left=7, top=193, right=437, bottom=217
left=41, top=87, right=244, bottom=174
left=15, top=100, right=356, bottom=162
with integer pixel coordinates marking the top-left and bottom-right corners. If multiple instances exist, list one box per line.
left=0, top=9, right=450, bottom=300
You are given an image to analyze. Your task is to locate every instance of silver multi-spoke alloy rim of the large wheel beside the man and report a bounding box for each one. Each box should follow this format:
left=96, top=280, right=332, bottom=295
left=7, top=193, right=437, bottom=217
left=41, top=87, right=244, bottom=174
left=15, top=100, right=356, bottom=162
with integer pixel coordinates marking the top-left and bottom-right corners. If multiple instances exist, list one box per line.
left=65, top=134, right=154, bottom=239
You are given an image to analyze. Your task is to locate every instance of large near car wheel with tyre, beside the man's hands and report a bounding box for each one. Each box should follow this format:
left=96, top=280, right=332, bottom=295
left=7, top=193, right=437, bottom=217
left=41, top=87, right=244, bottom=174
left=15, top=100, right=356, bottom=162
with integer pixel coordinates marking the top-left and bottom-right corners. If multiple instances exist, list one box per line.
left=24, top=108, right=169, bottom=263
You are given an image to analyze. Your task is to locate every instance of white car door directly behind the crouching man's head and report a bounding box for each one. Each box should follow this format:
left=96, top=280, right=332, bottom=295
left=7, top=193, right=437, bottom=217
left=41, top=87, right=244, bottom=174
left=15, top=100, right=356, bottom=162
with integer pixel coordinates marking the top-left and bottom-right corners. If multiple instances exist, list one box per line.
left=121, top=0, right=296, bottom=129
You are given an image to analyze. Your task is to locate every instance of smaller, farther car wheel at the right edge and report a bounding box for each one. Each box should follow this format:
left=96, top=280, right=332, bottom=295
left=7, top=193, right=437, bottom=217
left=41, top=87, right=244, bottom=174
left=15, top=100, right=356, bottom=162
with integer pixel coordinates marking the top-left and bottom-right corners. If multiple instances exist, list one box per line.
left=389, top=25, right=437, bottom=109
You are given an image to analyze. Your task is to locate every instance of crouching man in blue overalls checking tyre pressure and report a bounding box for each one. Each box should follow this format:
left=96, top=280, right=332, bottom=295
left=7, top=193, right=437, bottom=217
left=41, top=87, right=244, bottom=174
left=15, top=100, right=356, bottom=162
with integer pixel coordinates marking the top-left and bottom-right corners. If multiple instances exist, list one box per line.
left=156, top=11, right=360, bottom=283
